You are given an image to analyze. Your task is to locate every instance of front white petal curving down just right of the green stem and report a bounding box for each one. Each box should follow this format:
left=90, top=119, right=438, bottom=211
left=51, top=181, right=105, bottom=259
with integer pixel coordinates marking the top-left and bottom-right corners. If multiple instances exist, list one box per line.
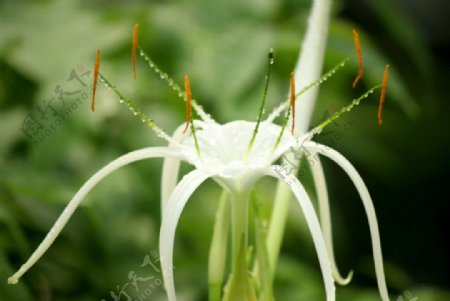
left=267, top=165, right=336, bottom=301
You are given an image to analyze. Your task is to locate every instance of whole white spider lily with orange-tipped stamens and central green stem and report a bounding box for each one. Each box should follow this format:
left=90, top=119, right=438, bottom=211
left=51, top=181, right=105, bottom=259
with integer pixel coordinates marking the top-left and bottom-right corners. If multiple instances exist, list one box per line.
left=8, top=14, right=388, bottom=301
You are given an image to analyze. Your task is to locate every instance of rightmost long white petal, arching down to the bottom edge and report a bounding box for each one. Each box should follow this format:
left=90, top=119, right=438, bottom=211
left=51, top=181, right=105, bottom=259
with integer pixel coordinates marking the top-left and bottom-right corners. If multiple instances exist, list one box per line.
left=303, top=141, right=389, bottom=301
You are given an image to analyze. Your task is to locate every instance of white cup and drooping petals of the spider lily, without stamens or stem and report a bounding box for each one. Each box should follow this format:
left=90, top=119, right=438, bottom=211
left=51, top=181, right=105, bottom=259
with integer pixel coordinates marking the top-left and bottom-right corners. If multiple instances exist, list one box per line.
left=9, top=92, right=388, bottom=301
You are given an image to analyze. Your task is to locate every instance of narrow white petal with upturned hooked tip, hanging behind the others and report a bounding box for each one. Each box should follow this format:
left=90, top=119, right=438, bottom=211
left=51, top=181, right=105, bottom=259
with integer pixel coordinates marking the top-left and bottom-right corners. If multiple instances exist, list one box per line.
left=307, top=152, right=353, bottom=285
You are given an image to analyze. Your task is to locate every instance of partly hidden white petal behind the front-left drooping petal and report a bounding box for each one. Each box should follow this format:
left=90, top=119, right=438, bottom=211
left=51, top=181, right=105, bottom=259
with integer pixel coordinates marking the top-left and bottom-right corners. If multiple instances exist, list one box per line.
left=161, top=124, right=189, bottom=213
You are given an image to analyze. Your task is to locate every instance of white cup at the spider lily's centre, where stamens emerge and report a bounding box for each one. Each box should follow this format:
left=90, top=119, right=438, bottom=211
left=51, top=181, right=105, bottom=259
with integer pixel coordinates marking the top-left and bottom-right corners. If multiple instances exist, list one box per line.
left=181, top=121, right=295, bottom=192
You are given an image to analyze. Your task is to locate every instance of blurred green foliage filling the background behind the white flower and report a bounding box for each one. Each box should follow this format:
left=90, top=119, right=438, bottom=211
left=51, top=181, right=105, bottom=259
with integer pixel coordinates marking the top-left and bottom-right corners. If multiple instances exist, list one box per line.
left=0, top=0, right=450, bottom=301
